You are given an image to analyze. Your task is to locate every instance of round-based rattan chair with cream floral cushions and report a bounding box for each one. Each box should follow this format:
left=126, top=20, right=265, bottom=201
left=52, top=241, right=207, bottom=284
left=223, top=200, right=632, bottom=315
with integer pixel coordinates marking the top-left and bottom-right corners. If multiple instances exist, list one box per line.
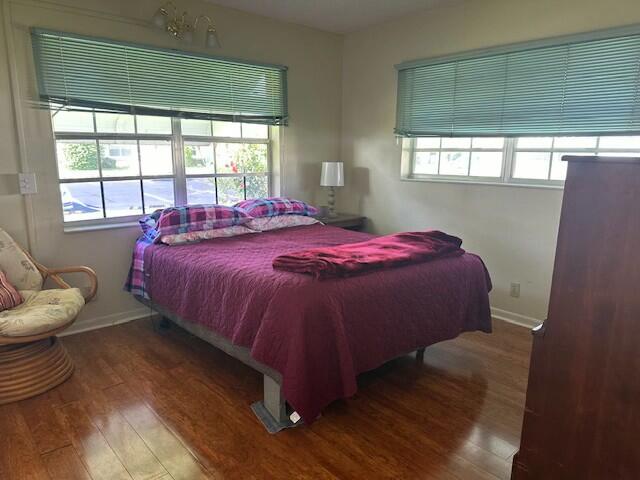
left=0, top=228, right=98, bottom=405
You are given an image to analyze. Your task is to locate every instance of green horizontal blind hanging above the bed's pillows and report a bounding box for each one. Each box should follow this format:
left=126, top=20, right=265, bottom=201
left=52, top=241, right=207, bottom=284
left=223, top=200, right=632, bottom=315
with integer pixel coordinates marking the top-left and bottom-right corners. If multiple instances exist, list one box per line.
left=32, top=29, right=288, bottom=125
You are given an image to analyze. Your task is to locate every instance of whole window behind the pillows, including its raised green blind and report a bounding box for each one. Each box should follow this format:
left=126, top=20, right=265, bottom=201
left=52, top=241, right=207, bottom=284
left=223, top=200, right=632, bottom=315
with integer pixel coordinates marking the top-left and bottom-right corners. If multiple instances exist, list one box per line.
left=32, top=30, right=287, bottom=230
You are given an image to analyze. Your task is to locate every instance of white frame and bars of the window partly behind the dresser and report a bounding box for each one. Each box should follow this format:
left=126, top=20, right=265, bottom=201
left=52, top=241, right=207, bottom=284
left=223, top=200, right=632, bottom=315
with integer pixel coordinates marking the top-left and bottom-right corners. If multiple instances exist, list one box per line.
left=401, top=135, right=640, bottom=189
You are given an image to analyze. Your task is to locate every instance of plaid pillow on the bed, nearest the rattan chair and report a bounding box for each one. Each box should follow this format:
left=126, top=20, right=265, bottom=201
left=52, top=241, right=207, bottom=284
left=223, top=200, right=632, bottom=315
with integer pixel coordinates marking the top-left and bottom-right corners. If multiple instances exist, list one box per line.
left=156, top=205, right=251, bottom=236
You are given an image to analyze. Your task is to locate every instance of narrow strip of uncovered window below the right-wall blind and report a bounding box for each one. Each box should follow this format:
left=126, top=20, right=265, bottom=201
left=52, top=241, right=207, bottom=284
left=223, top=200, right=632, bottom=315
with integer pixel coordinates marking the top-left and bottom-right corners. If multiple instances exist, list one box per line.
left=403, top=135, right=640, bottom=186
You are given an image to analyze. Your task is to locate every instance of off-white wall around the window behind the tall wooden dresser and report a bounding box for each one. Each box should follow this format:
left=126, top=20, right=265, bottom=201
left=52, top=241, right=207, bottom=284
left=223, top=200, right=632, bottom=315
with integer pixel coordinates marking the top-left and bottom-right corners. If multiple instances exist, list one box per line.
left=339, top=0, right=640, bottom=319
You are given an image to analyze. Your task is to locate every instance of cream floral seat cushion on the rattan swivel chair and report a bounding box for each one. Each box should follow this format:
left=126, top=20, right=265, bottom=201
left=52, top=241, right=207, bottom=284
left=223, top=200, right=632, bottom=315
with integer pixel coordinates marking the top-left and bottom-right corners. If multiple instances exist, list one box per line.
left=0, top=288, right=84, bottom=337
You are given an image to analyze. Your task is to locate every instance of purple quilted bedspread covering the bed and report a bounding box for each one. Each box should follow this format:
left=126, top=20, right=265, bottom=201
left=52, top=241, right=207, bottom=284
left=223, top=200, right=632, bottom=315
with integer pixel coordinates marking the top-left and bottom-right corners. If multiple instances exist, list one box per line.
left=144, top=225, right=491, bottom=423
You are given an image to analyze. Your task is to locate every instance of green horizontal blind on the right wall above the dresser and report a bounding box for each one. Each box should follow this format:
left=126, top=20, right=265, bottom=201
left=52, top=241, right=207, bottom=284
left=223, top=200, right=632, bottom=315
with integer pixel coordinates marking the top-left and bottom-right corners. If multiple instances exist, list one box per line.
left=395, top=27, right=640, bottom=137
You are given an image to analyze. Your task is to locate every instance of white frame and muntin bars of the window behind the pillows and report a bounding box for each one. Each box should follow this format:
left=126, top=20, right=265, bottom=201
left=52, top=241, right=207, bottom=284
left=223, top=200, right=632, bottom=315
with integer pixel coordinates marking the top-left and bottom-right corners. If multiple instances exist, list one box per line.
left=51, top=111, right=278, bottom=232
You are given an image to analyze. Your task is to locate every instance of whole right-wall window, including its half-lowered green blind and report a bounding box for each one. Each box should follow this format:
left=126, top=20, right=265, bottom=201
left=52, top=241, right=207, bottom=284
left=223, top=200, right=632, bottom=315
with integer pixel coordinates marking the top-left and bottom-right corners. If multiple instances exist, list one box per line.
left=394, top=25, right=640, bottom=187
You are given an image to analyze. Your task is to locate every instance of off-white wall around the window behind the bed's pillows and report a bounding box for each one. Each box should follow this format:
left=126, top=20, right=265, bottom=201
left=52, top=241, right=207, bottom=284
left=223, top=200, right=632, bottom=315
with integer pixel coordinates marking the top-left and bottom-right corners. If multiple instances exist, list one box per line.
left=0, top=0, right=342, bottom=329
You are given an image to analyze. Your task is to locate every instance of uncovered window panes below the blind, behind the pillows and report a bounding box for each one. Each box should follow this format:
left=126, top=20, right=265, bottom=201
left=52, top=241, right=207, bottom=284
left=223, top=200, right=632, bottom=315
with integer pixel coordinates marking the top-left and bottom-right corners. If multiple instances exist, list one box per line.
left=52, top=109, right=271, bottom=225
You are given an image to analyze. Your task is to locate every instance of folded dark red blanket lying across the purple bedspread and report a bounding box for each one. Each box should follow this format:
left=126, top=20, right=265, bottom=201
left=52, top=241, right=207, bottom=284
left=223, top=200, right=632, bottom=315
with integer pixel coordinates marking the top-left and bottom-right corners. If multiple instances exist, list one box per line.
left=273, top=230, right=464, bottom=278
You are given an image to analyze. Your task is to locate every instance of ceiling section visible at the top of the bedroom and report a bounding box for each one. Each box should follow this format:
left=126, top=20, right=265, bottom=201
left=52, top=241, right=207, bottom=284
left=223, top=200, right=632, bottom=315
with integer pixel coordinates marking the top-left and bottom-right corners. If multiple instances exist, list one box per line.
left=208, top=0, right=456, bottom=33
